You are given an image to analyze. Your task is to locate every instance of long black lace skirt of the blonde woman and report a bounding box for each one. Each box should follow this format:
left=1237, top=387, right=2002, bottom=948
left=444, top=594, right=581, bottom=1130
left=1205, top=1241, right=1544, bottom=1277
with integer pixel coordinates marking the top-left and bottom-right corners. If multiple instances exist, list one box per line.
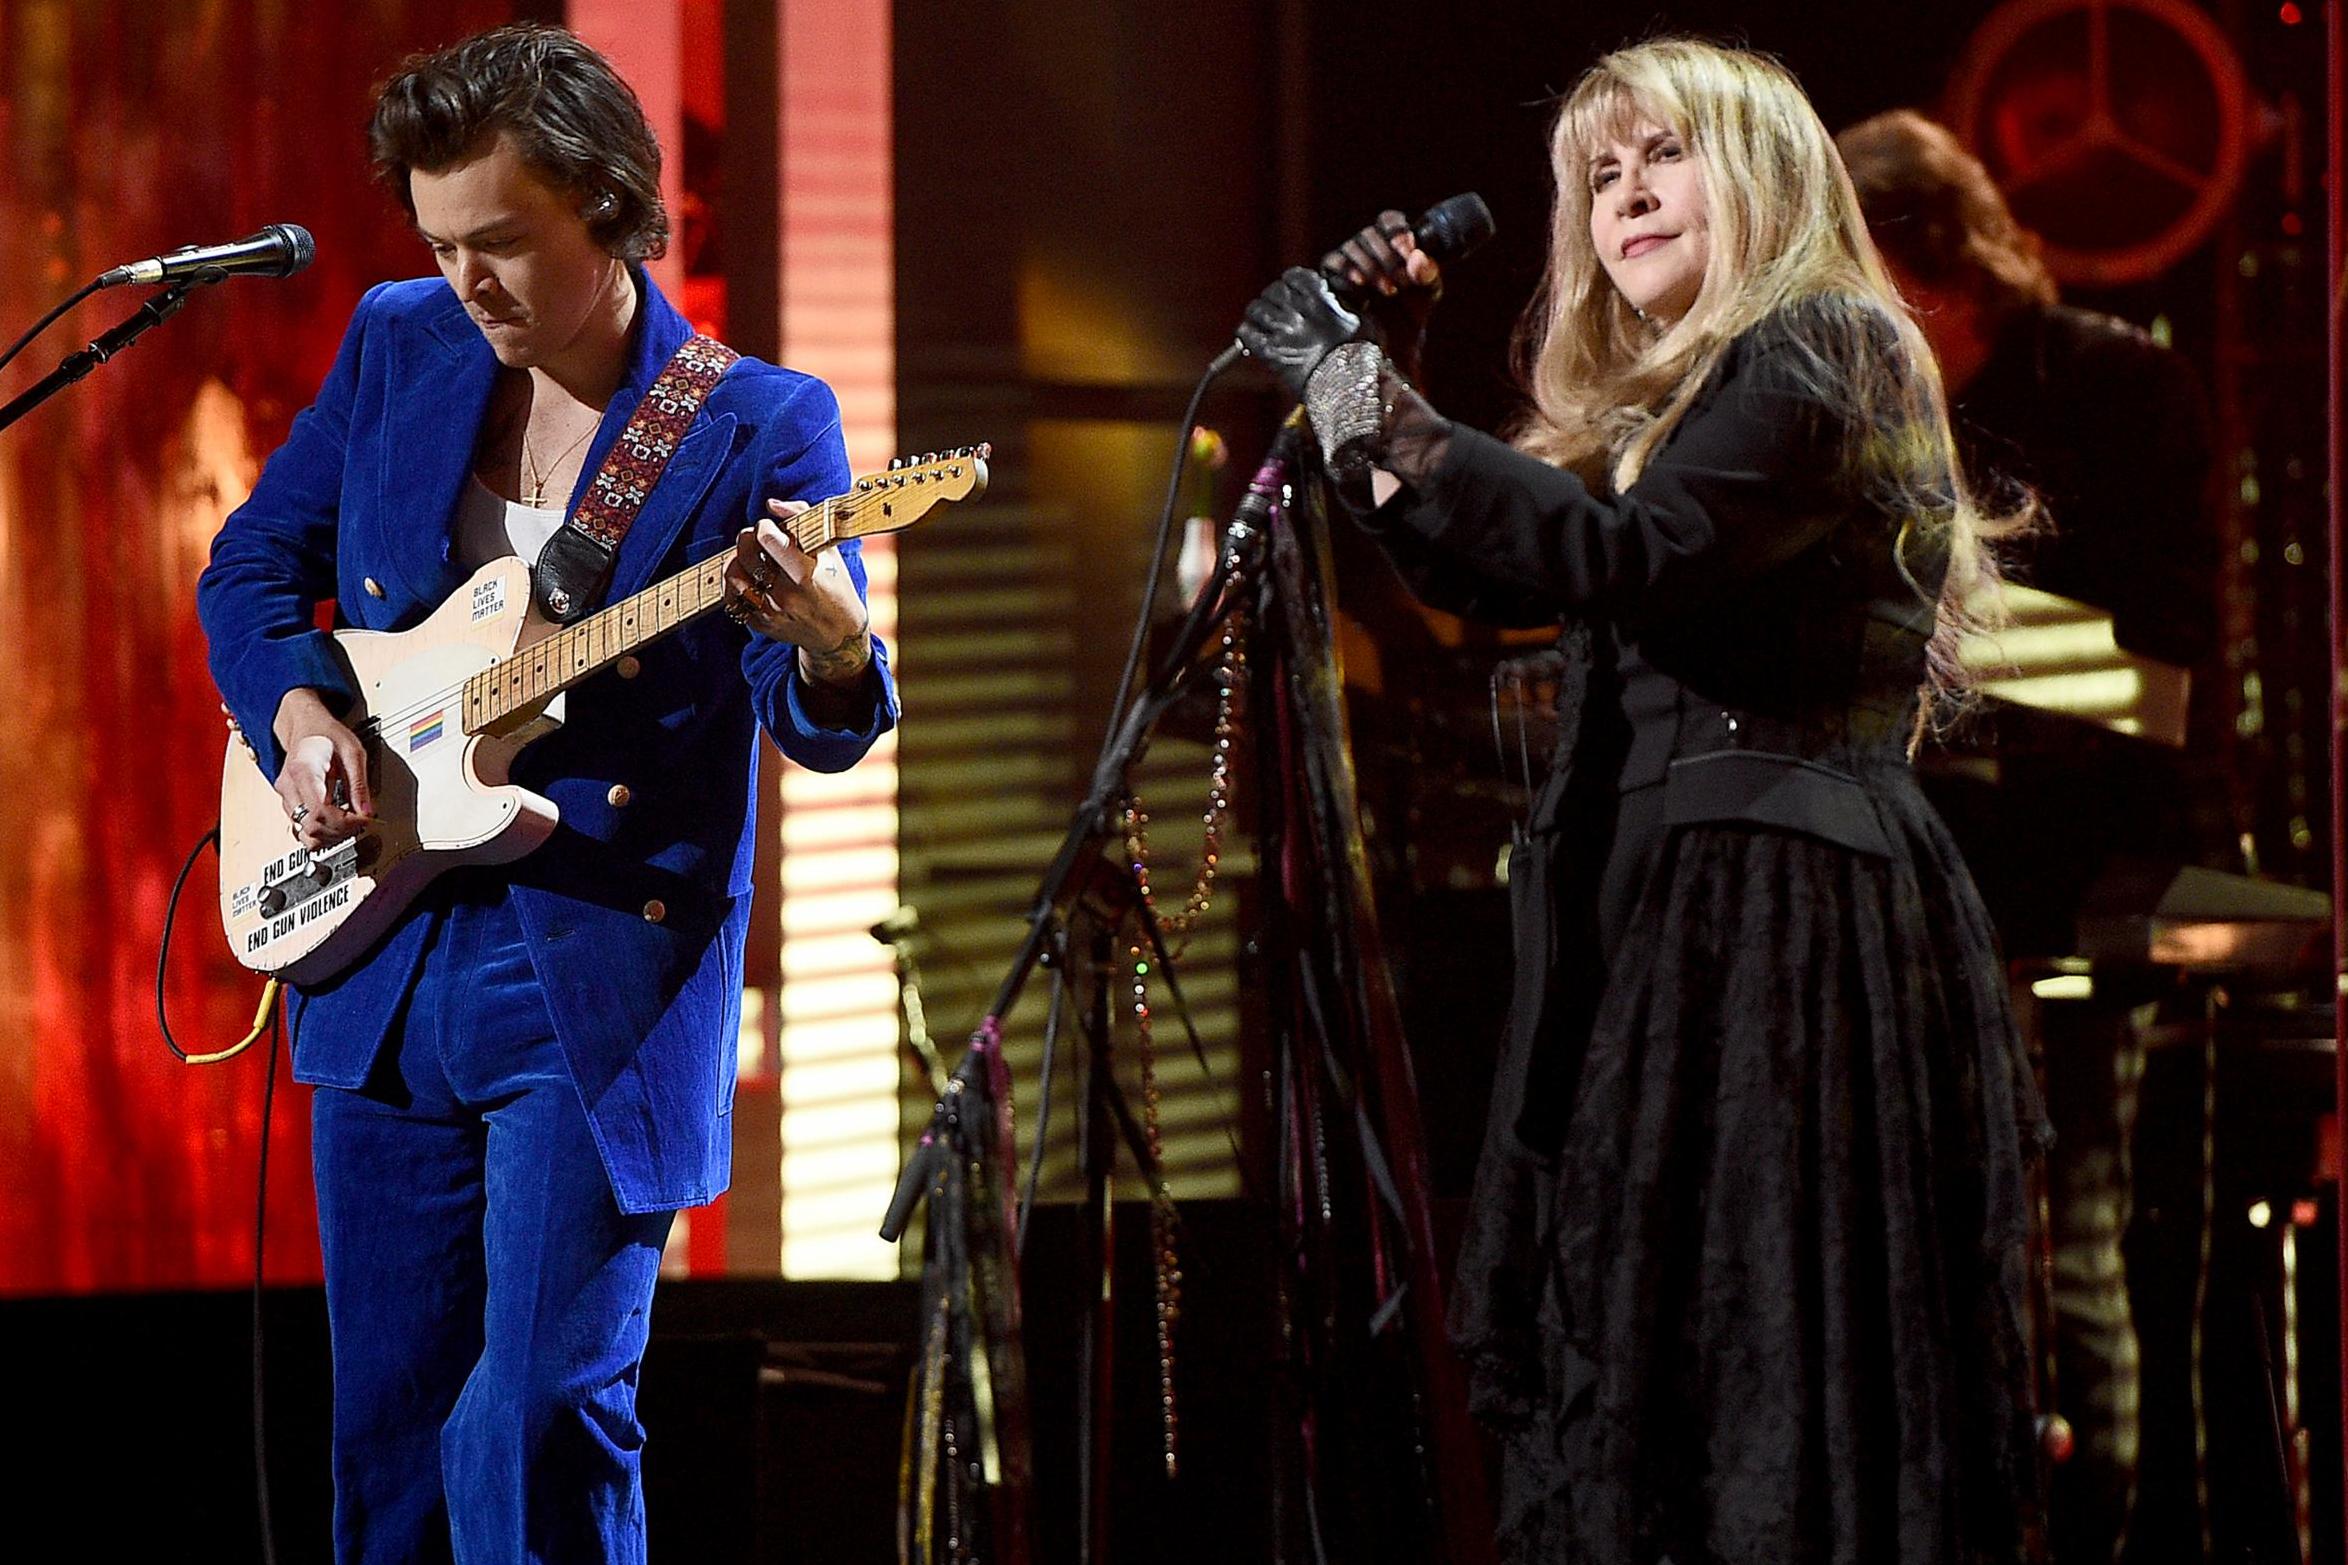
left=1453, top=767, right=2043, bottom=1565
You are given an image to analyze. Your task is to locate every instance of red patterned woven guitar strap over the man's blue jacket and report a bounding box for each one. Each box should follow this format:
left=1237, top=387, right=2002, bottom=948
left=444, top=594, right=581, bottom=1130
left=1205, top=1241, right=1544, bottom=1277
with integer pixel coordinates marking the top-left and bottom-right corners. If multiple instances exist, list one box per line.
left=531, top=333, right=742, bottom=624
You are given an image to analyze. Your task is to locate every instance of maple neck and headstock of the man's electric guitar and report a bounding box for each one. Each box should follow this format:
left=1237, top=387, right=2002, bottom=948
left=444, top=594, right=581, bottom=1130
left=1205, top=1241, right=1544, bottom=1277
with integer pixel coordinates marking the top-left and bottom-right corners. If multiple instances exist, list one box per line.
left=465, top=446, right=989, bottom=734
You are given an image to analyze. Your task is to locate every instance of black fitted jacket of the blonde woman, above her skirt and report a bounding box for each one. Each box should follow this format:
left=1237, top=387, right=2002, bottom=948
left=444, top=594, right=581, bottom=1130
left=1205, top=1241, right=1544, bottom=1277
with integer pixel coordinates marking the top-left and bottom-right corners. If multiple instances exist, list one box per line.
left=1364, top=300, right=1944, bottom=854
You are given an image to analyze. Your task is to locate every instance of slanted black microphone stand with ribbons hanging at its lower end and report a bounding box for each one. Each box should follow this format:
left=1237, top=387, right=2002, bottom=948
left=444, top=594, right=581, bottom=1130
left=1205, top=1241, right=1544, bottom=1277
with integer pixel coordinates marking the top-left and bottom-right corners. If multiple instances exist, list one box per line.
left=881, top=425, right=1301, bottom=1565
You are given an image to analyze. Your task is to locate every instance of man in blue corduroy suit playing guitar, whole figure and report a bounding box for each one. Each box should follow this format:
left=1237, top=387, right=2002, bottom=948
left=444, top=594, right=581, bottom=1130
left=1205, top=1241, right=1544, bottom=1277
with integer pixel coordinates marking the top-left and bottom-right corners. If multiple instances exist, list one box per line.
left=197, top=26, right=897, bottom=1560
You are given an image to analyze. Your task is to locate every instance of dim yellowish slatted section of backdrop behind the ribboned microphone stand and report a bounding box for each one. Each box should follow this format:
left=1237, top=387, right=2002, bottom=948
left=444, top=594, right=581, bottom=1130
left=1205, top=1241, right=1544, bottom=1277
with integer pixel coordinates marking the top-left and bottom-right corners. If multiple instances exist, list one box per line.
left=902, top=420, right=1251, bottom=1229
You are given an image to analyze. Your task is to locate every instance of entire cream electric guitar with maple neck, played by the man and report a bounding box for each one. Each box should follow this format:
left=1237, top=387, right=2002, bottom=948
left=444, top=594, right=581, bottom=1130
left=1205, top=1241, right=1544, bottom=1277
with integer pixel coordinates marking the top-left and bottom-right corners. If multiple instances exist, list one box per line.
left=221, top=446, right=991, bottom=983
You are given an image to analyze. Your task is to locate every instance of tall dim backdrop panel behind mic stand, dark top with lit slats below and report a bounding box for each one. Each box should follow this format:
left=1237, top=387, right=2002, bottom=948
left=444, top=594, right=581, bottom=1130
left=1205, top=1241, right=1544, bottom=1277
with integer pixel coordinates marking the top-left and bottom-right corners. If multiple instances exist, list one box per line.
left=895, top=0, right=1280, bottom=1248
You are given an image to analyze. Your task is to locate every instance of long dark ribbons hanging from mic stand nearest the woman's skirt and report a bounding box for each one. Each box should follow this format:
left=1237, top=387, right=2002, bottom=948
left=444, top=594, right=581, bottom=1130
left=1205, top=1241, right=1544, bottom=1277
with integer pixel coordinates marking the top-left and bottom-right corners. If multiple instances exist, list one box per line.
left=1249, top=445, right=1493, bottom=1565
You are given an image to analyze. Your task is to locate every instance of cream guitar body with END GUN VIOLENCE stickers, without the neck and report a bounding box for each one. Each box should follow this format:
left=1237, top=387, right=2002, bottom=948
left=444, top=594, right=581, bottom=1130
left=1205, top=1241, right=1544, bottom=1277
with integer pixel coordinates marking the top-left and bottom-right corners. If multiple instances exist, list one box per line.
left=221, top=556, right=564, bottom=983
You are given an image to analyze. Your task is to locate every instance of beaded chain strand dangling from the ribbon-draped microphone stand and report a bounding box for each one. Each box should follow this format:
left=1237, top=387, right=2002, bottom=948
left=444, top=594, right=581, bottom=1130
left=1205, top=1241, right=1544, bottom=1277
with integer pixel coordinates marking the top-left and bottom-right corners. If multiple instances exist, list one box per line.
left=1125, top=610, right=1247, bottom=1478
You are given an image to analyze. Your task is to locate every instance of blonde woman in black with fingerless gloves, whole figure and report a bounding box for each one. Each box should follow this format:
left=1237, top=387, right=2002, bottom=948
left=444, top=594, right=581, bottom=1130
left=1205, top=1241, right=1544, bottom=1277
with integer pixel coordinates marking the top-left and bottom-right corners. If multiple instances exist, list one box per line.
left=1242, top=40, right=2040, bottom=1565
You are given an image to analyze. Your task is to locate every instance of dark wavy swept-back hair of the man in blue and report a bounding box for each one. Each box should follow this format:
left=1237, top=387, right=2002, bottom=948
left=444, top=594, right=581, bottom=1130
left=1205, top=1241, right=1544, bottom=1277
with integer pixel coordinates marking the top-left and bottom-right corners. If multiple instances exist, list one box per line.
left=366, top=21, right=669, bottom=260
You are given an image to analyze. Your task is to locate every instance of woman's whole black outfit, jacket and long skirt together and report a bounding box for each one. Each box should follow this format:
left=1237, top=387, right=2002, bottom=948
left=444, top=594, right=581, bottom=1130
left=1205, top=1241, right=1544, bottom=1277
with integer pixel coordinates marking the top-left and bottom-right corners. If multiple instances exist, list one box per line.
left=1369, top=300, right=2040, bottom=1565
